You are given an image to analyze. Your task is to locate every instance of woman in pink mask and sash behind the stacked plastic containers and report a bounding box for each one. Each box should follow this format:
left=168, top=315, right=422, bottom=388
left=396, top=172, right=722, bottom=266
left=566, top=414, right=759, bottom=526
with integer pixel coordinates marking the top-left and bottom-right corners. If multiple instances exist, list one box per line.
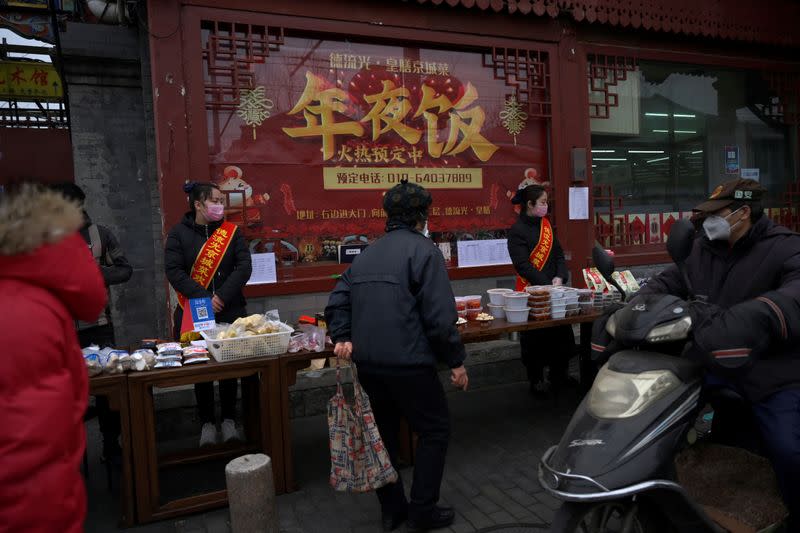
left=508, top=185, right=575, bottom=397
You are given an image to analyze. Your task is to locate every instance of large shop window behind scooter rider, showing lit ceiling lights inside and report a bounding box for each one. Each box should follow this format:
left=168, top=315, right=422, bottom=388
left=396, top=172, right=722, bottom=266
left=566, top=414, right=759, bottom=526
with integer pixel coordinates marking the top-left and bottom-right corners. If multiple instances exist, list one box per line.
left=589, top=56, right=797, bottom=247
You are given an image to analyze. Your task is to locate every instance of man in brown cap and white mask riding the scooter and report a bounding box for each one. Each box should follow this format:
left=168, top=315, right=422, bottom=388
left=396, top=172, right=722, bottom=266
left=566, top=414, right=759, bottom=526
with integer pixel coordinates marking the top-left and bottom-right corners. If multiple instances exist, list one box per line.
left=640, top=179, right=800, bottom=531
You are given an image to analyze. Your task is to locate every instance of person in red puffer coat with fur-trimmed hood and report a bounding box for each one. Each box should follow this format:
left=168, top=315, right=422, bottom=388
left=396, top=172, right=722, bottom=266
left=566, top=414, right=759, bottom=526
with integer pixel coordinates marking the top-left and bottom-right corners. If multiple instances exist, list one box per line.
left=0, top=185, right=106, bottom=533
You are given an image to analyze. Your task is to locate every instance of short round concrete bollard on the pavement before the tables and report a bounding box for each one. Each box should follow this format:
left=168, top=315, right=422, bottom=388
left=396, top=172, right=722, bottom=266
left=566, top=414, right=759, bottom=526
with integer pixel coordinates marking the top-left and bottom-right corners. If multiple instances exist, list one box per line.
left=225, top=453, right=279, bottom=533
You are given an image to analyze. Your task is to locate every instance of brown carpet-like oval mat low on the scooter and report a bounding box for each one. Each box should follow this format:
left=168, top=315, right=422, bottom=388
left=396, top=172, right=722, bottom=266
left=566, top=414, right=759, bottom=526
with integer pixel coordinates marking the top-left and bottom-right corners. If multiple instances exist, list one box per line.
left=675, top=443, right=787, bottom=531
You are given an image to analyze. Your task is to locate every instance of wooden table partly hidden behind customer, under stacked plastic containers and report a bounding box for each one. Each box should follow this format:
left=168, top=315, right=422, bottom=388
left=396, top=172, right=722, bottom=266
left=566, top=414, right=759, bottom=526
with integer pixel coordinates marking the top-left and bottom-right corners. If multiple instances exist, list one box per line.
left=279, top=313, right=600, bottom=492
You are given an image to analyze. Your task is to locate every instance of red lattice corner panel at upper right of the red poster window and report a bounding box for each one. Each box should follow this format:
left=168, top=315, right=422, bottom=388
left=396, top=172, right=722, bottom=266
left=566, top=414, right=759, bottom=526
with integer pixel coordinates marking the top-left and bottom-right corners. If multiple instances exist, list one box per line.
left=483, top=48, right=553, bottom=118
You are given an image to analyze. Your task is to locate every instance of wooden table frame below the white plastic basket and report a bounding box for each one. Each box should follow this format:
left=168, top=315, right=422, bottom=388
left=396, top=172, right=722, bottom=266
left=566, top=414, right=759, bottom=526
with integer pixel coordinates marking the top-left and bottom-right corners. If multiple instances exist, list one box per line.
left=128, top=357, right=285, bottom=522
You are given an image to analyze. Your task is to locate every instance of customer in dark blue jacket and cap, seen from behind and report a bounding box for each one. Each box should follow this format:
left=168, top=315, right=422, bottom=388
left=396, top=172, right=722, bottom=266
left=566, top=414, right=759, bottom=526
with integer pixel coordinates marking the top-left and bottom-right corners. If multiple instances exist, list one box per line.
left=325, top=183, right=468, bottom=531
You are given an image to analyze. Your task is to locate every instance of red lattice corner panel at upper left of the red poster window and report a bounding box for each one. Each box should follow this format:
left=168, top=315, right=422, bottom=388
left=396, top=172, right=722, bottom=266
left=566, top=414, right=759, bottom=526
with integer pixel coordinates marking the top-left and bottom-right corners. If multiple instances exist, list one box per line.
left=201, top=21, right=283, bottom=109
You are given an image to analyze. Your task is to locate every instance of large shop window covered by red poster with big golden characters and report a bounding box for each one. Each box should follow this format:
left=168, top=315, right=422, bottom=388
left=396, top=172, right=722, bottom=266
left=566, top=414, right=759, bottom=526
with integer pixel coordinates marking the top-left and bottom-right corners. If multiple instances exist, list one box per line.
left=202, top=21, right=550, bottom=281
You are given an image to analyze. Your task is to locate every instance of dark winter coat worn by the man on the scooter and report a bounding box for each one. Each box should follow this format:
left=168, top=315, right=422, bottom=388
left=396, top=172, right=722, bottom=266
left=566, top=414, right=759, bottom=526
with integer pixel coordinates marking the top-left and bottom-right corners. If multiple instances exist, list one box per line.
left=640, top=217, right=800, bottom=401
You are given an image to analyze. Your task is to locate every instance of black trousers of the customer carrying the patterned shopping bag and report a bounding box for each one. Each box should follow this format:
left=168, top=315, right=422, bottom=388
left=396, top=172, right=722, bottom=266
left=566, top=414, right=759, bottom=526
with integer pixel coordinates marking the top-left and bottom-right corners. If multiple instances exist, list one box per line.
left=359, top=368, right=450, bottom=519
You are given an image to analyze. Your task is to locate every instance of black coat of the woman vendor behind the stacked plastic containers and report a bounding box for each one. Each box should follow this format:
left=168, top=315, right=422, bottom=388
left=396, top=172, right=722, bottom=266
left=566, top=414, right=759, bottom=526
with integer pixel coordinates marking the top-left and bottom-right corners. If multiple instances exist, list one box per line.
left=508, top=213, right=569, bottom=285
